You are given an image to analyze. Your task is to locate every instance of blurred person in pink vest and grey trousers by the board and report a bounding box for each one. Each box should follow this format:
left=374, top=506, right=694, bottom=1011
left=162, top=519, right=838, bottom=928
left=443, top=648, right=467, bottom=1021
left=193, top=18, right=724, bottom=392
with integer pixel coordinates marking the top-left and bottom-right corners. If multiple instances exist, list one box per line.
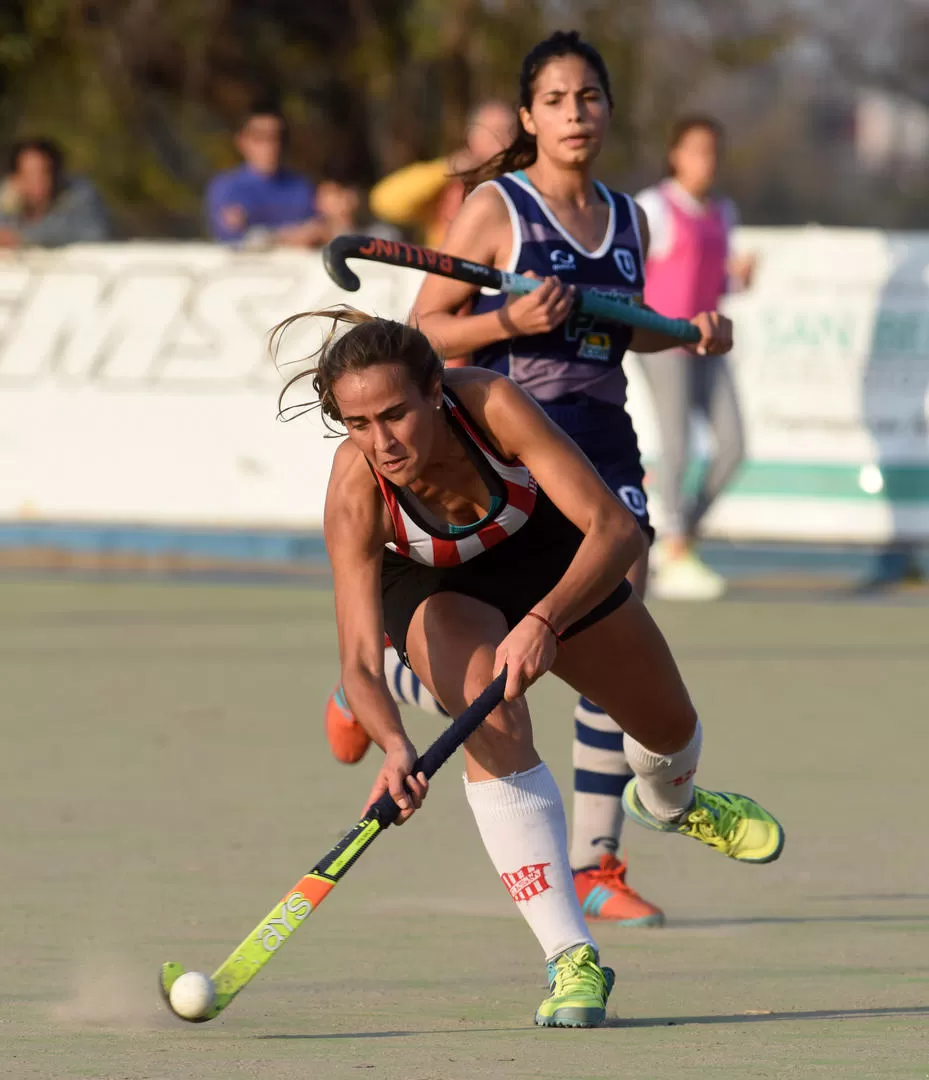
left=636, top=116, right=754, bottom=599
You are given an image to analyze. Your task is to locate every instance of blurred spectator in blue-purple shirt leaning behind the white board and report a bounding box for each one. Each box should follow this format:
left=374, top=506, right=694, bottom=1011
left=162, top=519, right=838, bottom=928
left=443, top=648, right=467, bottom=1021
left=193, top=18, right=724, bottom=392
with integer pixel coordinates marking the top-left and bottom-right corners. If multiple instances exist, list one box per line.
left=206, top=103, right=326, bottom=247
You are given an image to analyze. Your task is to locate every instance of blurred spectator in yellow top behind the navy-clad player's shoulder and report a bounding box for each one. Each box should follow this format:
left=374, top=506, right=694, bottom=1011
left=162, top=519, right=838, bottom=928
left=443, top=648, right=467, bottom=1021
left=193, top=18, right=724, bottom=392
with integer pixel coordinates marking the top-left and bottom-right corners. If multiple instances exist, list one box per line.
left=371, top=102, right=516, bottom=247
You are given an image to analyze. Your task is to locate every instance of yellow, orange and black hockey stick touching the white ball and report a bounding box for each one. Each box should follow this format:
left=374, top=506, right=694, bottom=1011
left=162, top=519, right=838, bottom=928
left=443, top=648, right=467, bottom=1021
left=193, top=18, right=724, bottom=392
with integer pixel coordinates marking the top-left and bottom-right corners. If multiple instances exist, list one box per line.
left=159, top=669, right=507, bottom=1024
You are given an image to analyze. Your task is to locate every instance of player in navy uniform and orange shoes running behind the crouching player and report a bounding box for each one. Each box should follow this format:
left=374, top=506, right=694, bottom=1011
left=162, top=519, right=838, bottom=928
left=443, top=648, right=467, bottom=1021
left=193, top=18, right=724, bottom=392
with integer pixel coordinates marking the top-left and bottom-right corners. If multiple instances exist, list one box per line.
left=326, top=33, right=719, bottom=926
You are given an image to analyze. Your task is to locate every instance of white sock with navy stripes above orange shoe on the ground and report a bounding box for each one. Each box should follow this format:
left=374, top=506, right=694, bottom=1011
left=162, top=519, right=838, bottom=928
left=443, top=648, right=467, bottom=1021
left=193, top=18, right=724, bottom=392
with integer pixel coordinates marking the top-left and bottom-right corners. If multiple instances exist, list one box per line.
left=571, top=698, right=633, bottom=870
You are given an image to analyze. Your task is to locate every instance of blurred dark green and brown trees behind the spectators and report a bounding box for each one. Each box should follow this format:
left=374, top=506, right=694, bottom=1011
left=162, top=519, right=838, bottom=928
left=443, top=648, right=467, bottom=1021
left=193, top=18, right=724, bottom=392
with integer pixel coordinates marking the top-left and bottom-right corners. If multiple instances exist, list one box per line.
left=0, top=0, right=929, bottom=235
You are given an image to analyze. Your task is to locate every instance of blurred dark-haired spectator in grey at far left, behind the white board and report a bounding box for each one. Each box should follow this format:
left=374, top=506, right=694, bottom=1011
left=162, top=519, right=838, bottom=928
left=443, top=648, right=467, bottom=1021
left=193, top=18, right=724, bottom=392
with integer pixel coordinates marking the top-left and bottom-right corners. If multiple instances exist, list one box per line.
left=0, top=138, right=111, bottom=247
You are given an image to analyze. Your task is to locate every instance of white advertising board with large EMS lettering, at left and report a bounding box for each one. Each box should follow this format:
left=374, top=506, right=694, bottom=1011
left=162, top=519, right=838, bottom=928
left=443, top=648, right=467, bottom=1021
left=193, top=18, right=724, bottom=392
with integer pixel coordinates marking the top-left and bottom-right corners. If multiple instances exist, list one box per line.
left=0, top=244, right=418, bottom=528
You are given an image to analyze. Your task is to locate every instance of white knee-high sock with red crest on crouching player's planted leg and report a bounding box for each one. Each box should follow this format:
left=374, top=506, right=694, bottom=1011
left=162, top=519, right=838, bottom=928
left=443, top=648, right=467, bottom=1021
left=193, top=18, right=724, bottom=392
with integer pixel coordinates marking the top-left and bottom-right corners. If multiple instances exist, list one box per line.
left=465, top=764, right=596, bottom=960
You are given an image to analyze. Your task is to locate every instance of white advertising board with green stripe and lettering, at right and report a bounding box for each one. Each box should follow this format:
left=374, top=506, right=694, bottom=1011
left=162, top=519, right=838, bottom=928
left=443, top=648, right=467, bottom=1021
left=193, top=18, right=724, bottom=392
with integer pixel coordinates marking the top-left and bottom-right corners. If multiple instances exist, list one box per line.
left=628, top=227, right=929, bottom=542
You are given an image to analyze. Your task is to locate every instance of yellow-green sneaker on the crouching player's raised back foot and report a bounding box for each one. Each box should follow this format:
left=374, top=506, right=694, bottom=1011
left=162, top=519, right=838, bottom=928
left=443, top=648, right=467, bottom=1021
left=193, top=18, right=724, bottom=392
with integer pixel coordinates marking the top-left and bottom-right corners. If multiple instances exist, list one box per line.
left=622, top=778, right=784, bottom=863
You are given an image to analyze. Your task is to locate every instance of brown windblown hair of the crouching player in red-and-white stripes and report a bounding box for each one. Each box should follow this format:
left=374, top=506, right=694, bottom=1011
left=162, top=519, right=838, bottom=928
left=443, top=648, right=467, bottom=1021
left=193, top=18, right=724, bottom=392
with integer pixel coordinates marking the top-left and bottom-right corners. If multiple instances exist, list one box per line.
left=270, top=305, right=443, bottom=434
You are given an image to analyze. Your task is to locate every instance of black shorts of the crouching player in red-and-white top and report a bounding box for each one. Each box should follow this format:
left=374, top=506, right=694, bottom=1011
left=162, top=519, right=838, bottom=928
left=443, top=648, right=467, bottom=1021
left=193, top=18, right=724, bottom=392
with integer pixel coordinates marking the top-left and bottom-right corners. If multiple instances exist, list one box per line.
left=380, top=488, right=632, bottom=667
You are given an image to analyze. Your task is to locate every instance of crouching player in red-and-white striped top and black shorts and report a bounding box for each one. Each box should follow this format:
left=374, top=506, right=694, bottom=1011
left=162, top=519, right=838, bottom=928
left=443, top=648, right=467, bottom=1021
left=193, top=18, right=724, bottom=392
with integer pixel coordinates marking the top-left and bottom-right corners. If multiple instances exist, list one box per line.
left=275, top=309, right=783, bottom=1027
